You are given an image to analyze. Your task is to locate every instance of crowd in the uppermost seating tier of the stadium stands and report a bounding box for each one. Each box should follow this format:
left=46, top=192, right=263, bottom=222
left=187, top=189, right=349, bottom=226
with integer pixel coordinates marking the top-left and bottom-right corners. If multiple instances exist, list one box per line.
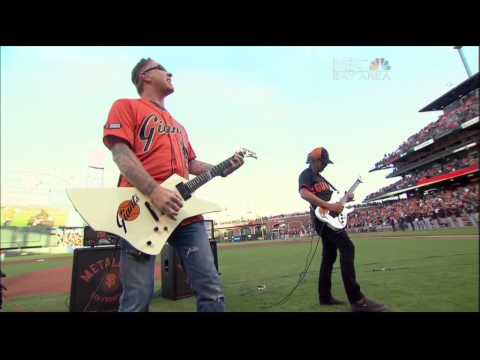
left=375, top=89, right=479, bottom=169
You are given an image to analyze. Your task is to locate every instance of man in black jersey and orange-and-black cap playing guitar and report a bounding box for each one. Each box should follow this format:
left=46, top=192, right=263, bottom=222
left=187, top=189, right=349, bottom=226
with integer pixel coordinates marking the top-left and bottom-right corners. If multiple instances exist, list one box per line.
left=298, top=147, right=385, bottom=312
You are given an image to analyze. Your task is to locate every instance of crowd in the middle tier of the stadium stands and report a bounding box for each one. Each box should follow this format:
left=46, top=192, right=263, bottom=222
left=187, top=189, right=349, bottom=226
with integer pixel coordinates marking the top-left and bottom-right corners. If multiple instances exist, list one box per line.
left=365, top=154, right=478, bottom=201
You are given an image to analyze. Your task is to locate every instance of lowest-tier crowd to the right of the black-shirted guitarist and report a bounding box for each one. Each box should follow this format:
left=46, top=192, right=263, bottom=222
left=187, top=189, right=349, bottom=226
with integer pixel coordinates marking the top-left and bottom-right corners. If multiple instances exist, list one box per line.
left=347, top=183, right=479, bottom=232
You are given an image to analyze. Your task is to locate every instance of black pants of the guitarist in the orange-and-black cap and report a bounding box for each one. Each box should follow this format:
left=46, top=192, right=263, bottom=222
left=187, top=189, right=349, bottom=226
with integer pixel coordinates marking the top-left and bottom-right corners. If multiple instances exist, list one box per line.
left=314, top=219, right=363, bottom=304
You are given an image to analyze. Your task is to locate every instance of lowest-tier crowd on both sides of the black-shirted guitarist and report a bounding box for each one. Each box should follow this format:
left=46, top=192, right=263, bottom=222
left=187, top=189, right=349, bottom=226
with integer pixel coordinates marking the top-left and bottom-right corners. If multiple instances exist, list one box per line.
left=216, top=181, right=480, bottom=241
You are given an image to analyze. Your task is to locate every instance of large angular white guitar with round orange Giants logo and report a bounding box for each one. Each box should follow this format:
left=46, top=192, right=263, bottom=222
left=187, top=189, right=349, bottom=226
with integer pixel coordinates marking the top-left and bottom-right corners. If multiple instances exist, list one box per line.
left=67, top=148, right=257, bottom=255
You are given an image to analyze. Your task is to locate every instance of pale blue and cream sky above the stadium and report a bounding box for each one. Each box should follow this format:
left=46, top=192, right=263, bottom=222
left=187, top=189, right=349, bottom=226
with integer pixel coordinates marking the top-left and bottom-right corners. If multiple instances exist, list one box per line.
left=0, top=46, right=479, bottom=226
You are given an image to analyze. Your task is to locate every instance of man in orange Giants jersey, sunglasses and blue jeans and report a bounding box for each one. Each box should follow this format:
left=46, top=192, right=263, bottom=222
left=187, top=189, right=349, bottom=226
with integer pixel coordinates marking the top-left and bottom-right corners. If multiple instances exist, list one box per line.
left=103, top=59, right=243, bottom=312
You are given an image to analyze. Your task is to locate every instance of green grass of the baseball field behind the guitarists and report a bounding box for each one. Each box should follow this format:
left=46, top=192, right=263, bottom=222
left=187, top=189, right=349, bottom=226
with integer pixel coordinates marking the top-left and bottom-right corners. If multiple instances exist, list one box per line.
left=2, top=228, right=479, bottom=312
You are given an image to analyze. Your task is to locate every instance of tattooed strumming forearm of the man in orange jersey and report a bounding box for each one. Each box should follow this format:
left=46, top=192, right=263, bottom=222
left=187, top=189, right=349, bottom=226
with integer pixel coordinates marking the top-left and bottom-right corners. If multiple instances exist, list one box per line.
left=112, top=143, right=157, bottom=195
